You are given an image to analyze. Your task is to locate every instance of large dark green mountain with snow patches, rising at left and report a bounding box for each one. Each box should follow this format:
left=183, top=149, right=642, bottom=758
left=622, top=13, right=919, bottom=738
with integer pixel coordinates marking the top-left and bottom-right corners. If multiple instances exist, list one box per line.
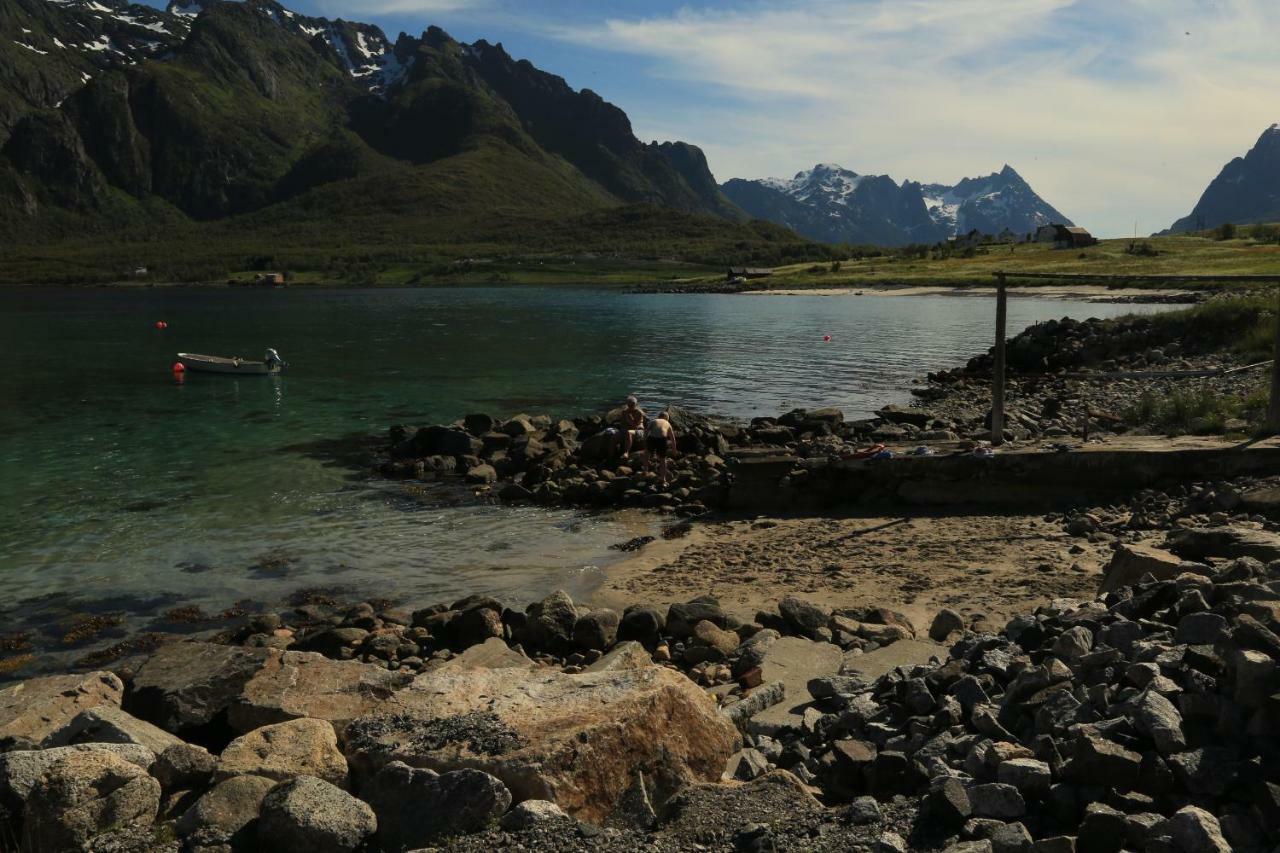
left=0, top=0, right=831, bottom=275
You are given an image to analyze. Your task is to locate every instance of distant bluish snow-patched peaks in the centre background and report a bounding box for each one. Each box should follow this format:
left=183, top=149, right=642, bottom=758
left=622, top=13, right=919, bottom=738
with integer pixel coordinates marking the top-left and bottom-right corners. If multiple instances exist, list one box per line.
left=721, top=164, right=1073, bottom=246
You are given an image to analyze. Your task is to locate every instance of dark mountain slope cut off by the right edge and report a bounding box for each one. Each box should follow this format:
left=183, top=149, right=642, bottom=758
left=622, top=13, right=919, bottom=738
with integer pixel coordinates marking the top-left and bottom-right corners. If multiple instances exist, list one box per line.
left=1164, top=124, right=1280, bottom=233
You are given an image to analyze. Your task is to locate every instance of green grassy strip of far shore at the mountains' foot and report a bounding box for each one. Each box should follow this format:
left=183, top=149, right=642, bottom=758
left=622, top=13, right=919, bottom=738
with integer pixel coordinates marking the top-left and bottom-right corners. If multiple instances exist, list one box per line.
left=0, top=227, right=1280, bottom=292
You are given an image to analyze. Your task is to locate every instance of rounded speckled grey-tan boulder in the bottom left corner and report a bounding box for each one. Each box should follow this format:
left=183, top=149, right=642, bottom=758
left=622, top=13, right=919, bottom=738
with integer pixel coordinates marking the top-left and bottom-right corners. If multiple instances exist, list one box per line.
left=22, top=751, right=160, bottom=850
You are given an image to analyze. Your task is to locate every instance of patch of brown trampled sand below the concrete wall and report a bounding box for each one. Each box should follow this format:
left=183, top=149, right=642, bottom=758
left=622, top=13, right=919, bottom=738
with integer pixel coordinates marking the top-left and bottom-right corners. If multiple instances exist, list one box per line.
left=593, top=504, right=1110, bottom=630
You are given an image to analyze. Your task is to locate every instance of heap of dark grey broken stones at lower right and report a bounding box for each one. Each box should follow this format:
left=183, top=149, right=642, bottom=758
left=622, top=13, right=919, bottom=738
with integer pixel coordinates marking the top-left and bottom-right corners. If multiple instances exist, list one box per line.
left=746, top=557, right=1280, bottom=853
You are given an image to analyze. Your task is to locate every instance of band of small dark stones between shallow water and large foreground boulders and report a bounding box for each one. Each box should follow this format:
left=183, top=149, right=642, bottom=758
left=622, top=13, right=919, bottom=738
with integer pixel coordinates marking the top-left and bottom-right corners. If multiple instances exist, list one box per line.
left=202, top=590, right=915, bottom=685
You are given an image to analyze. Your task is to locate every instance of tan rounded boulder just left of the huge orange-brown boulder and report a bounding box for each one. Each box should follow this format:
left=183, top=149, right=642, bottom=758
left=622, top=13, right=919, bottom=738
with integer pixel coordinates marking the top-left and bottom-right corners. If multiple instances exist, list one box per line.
left=215, top=719, right=347, bottom=785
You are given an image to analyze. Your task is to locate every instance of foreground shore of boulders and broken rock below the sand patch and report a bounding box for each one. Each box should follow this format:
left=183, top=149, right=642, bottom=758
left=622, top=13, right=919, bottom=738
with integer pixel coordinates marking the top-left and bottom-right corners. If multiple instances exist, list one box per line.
left=0, top=521, right=1280, bottom=853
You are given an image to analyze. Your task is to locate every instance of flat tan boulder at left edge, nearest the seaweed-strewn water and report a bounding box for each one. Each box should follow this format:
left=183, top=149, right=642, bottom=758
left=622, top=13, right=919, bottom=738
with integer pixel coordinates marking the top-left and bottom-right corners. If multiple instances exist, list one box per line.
left=0, top=672, right=124, bottom=752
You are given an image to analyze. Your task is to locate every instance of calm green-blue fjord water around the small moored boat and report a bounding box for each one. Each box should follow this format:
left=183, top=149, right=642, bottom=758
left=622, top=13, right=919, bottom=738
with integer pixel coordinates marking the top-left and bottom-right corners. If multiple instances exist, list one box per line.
left=0, top=288, right=1162, bottom=645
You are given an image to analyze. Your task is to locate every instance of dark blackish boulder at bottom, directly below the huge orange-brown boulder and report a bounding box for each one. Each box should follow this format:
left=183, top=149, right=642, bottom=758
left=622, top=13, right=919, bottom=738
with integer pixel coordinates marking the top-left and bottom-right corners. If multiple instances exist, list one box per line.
left=361, top=761, right=511, bottom=850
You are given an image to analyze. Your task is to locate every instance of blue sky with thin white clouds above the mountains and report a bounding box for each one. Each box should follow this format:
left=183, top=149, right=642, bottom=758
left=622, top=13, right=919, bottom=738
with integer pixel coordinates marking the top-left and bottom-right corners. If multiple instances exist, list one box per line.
left=147, top=0, right=1280, bottom=237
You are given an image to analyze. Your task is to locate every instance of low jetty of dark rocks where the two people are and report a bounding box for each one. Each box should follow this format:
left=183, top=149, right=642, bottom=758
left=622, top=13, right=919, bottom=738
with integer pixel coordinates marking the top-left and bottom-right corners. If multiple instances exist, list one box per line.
left=378, top=406, right=998, bottom=507
